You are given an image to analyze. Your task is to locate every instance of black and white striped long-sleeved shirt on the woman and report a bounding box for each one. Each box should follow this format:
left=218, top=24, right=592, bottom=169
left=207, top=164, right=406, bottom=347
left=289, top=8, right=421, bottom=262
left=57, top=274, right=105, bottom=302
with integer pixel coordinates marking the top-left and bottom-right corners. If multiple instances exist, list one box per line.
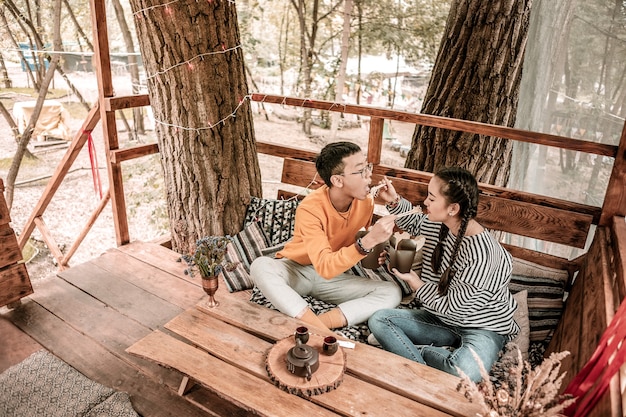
left=389, top=199, right=519, bottom=339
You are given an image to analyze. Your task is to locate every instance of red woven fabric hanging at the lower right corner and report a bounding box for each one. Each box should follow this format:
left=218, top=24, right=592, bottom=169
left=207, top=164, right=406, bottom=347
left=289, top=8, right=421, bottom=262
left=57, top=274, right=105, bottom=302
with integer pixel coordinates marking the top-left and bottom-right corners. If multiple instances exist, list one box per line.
left=564, top=294, right=626, bottom=417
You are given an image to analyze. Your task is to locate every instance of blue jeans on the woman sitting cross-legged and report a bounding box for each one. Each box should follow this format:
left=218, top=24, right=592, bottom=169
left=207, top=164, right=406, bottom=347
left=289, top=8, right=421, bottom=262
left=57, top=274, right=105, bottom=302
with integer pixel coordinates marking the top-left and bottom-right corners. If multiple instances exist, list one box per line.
left=368, top=309, right=505, bottom=382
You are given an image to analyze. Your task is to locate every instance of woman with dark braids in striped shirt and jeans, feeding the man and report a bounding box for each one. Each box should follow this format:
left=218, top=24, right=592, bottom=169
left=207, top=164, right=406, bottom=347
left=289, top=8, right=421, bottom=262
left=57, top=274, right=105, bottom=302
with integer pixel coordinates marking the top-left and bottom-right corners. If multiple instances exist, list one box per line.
left=368, top=167, right=519, bottom=381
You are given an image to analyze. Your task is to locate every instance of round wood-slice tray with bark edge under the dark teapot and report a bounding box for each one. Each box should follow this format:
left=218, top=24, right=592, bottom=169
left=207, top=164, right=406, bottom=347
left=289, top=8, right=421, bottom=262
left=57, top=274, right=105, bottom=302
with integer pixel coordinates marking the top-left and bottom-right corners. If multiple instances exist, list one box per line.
left=265, top=334, right=346, bottom=397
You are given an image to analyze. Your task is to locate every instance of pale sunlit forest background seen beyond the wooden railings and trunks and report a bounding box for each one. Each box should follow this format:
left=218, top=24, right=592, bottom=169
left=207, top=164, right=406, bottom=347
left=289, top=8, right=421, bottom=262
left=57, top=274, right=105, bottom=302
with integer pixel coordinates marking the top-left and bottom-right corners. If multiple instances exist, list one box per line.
left=0, top=0, right=626, bottom=275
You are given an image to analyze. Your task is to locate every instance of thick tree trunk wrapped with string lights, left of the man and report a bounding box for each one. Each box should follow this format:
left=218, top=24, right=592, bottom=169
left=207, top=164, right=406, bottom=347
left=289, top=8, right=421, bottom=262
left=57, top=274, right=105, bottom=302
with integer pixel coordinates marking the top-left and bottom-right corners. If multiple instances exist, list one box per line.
left=131, top=0, right=262, bottom=252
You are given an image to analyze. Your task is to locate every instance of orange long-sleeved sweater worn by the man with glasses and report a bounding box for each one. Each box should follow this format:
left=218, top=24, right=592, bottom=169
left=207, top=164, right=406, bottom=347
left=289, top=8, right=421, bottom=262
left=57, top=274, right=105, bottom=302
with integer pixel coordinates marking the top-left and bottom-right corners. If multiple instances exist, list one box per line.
left=276, top=185, right=374, bottom=279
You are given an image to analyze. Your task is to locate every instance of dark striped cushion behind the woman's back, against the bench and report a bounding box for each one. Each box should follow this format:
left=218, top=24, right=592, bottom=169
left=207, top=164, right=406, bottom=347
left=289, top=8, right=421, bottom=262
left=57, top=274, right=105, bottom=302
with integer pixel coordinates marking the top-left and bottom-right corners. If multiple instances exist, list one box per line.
left=509, top=258, right=568, bottom=343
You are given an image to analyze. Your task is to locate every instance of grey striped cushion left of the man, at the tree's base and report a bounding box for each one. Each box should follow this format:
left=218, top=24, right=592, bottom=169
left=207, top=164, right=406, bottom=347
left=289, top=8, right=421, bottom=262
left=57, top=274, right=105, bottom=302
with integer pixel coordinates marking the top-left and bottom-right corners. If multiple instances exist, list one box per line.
left=222, top=222, right=268, bottom=292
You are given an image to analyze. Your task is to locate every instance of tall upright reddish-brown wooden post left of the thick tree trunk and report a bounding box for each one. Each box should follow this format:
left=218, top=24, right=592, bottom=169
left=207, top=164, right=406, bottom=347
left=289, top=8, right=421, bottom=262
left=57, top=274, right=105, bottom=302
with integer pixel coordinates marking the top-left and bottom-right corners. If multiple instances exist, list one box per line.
left=89, top=0, right=130, bottom=246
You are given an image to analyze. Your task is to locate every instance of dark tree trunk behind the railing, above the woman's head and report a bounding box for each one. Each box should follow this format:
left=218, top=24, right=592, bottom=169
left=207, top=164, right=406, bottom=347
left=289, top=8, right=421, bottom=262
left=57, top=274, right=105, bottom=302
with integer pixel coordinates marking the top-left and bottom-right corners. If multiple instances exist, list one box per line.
left=405, top=0, right=532, bottom=185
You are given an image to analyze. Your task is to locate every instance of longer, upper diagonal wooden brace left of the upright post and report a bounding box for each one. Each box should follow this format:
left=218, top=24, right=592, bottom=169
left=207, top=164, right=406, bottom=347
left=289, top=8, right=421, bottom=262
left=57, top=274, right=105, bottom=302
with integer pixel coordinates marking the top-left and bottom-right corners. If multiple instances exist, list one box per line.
left=17, top=103, right=100, bottom=249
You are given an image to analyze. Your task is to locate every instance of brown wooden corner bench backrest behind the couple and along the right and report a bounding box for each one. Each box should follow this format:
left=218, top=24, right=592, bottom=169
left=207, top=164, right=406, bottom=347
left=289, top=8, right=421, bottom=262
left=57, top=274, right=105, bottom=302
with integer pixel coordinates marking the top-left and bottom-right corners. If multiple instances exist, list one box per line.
left=255, top=145, right=626, bottom=417
